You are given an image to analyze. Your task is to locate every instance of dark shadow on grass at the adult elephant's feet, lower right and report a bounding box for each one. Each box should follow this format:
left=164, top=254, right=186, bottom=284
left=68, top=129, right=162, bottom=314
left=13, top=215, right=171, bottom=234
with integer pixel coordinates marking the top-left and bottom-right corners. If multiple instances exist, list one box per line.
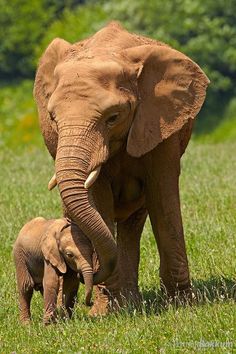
left=138, top=277, right=236, bottom=315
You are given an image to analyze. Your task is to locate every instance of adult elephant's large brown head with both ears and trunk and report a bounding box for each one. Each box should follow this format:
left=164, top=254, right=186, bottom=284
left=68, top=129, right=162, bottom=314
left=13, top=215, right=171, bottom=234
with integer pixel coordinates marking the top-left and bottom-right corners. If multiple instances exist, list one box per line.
left=34, top=25, right=209, bottom=280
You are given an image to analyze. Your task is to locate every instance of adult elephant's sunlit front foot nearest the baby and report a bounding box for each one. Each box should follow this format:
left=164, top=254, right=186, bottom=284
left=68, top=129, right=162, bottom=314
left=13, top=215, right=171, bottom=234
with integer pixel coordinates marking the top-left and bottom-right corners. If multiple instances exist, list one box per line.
left=89, top=285, right=121, bottom=317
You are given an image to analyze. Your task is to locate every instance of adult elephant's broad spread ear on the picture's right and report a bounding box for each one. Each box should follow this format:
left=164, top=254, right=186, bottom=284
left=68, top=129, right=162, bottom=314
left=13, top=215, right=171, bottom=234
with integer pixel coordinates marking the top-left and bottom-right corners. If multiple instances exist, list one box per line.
left=123, top=45, right=209, bottom=157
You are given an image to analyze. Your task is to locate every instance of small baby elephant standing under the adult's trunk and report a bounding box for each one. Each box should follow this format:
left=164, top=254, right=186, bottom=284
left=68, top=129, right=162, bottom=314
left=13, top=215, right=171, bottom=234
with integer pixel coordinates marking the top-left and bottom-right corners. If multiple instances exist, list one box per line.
left=13, top=217, right=93, bottom=324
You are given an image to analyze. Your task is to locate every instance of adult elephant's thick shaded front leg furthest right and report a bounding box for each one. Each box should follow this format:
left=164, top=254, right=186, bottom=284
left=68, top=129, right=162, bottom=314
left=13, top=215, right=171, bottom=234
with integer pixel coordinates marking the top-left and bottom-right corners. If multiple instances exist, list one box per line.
left=144, top=135, right=191, bottom=297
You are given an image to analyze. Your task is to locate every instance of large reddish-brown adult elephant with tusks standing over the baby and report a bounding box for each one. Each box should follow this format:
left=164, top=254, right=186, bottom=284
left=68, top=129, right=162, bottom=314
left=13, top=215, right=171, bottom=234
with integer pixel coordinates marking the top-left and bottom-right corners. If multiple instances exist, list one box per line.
left=34, top=22, right=209, bottom=314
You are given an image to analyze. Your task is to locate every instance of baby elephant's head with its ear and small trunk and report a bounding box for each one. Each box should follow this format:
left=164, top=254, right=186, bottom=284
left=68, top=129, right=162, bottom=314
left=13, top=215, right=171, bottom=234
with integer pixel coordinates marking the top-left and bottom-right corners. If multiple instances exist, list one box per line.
left=42, top=219, right=93, bottom=305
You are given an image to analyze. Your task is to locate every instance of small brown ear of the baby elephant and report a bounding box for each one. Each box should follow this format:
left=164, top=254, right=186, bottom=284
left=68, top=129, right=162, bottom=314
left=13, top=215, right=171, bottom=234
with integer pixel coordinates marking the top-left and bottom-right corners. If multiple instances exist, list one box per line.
left=42, top=219, right=66, bottom=274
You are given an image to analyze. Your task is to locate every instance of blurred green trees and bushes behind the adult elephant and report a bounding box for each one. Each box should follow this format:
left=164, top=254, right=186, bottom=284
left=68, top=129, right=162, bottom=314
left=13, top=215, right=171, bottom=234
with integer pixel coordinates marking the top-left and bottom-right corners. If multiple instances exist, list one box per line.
left=0, top=0, right=236, bottom=144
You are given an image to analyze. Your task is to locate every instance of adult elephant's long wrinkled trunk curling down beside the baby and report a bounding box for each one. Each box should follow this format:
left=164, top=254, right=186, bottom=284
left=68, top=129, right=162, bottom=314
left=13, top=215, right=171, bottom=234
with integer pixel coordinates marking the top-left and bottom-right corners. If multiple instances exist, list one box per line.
left=56, top=123, right=117, bottom=284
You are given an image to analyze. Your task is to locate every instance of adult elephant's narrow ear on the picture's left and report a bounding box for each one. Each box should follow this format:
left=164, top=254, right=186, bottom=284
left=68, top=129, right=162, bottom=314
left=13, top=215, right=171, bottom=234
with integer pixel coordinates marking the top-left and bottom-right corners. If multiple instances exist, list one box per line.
left=34, top=38, right=71, bottom=158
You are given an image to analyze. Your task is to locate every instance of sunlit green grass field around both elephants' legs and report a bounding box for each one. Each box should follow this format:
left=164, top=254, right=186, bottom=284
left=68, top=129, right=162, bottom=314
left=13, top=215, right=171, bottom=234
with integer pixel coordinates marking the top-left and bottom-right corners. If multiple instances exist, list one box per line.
left=0, top=142, right=236, bottom=354
